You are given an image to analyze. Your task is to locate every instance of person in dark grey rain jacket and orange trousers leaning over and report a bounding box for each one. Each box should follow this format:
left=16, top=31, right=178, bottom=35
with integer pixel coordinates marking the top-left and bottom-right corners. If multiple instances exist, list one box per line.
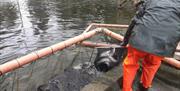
left=123, top=0, right=180, bottom=91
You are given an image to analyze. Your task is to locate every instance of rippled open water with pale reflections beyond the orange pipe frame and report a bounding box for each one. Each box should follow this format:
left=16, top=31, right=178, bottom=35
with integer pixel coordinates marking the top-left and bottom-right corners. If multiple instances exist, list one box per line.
left=0, top=0, right=133, bottom=62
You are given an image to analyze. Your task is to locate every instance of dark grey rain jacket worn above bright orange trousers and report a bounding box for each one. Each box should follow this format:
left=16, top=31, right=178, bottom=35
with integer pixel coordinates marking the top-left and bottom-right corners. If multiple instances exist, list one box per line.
left=129, top=0, right=180, bottom=57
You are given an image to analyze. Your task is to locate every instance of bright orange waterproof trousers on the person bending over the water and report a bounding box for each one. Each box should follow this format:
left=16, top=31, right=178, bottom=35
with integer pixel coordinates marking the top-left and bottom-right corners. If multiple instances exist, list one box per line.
left=123, top=46, right=163, bottom=91
